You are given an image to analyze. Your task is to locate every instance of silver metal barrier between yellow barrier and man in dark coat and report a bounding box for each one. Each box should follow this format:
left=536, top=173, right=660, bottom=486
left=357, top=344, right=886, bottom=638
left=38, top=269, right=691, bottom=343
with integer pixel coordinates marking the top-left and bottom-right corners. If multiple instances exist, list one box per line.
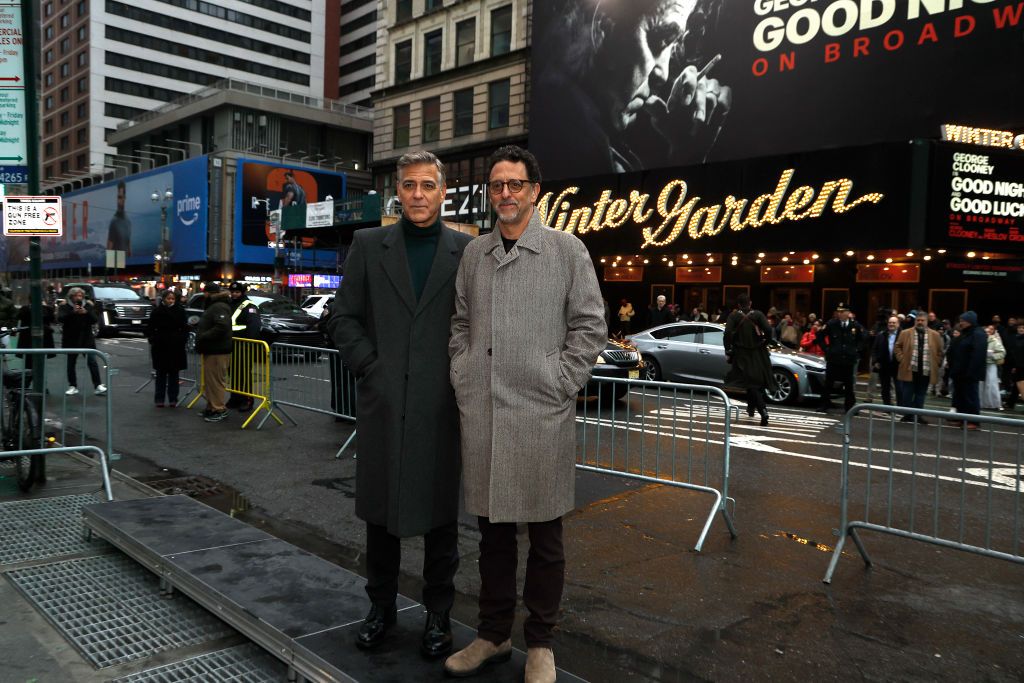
left=260, top=343, right=355, bottom=458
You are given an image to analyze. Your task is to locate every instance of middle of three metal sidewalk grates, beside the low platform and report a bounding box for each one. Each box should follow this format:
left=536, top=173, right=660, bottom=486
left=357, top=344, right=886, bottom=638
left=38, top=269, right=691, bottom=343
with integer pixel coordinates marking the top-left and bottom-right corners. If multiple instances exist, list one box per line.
left=7, top=554, right=236, bottom=669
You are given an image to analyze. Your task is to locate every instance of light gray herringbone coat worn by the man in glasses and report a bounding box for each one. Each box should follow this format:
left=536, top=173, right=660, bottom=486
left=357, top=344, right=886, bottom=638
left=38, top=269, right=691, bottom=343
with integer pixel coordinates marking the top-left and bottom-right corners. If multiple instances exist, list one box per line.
left=449, top=211, right=608, bottom=522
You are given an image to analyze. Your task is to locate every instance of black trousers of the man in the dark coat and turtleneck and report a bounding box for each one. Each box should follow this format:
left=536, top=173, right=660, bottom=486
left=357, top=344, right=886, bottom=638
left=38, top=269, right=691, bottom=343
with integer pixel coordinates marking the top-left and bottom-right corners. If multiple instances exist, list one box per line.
left=367, top=521, right=459, bottom=612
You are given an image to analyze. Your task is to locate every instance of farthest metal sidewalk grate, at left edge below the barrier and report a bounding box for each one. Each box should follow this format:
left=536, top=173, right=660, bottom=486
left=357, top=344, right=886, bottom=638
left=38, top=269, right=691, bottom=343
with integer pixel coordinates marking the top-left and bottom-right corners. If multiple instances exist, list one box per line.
left=0, top=494, right=111, bottom=566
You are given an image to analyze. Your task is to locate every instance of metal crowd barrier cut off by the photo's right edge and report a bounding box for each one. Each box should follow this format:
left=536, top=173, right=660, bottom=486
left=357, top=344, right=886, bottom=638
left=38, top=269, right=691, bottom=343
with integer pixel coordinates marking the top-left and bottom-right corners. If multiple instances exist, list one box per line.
left=823, top=403, right=1024, bottom=584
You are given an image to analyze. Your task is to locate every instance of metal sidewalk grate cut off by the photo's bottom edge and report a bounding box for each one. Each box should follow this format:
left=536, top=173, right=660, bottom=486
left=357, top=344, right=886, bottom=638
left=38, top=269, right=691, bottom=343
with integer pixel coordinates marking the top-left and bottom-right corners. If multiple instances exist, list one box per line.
left=111, top=643, right=288, bottom=683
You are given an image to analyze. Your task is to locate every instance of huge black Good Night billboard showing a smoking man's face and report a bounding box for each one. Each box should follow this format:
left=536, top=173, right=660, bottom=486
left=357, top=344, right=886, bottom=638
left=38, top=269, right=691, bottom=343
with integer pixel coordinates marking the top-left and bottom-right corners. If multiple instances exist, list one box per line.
left=529, top=0, right=1024, bottom=178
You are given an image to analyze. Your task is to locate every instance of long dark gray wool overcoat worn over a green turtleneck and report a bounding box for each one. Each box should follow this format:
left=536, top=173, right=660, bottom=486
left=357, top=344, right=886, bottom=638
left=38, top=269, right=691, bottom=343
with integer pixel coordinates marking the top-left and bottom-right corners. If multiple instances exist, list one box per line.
left=328, top=223, right=471, bottom=538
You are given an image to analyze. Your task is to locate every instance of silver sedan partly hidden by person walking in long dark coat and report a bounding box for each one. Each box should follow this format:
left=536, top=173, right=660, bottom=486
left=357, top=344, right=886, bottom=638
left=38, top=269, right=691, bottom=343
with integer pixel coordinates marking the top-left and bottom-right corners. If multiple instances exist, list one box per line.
left=628, top=323, right=825, bottom=403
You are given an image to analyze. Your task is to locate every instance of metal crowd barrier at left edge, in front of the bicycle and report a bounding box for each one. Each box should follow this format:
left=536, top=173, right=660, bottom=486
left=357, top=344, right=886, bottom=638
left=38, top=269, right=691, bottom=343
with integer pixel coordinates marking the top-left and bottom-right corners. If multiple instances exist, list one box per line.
left=0, top=348, right=115, bottom=501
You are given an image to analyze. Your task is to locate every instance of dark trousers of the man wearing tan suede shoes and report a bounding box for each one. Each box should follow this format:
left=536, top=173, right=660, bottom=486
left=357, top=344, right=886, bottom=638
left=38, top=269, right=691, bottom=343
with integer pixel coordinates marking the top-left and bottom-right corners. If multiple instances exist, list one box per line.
left=477, top=517, right=565, bottom=647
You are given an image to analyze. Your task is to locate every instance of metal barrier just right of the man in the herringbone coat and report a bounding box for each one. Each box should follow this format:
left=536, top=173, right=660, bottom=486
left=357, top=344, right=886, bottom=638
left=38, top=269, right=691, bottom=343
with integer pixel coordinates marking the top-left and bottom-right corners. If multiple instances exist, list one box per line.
left=577, top=377, right=736, bottom=552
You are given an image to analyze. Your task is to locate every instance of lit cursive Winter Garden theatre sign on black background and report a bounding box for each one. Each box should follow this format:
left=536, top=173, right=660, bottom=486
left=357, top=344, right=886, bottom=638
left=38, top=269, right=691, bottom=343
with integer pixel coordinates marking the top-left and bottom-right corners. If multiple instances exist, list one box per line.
left=537, top=144, right=910, bottom=253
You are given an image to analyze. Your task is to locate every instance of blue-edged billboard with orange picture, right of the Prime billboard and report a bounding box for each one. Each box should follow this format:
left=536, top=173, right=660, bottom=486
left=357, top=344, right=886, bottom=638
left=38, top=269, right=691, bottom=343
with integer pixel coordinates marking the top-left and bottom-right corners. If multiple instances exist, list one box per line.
left=234, top=159, right=346, bottom=268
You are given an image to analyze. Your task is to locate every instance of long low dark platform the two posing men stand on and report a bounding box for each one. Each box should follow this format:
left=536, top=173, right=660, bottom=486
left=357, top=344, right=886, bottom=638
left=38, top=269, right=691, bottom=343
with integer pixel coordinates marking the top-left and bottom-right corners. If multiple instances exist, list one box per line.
left=82, top=496, right=583, bottom=683
